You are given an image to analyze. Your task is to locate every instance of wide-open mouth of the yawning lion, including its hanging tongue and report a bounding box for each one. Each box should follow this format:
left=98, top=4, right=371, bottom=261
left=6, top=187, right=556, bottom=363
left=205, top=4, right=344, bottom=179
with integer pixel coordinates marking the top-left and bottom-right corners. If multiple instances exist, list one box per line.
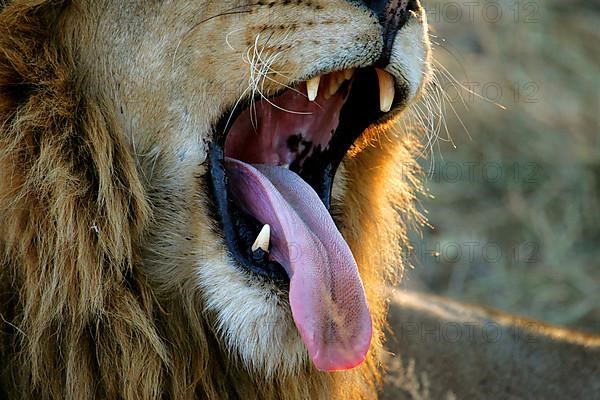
left=210, top=68, right=406, bottom=371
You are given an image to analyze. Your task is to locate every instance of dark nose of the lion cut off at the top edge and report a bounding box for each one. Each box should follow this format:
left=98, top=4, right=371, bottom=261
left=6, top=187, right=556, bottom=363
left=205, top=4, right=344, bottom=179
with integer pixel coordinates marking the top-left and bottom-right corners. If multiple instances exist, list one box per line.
left=364, top=0, right=420, bottom=66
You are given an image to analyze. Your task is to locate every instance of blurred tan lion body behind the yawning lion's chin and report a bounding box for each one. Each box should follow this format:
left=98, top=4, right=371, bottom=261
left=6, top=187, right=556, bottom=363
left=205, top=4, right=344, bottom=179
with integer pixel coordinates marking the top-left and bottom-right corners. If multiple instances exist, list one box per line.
left=381, top=290, right=600, bottom=400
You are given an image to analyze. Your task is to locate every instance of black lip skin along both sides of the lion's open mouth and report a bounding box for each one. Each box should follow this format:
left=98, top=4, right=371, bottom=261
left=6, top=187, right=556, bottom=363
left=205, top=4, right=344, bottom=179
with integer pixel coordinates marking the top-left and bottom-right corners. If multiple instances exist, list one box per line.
left=209, top=68, right=398, bottom=285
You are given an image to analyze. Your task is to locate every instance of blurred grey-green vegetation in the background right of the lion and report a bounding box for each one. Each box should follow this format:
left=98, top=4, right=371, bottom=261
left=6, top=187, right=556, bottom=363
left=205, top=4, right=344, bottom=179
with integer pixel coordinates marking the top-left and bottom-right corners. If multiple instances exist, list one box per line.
left=402, top=0, right=600, bottom=331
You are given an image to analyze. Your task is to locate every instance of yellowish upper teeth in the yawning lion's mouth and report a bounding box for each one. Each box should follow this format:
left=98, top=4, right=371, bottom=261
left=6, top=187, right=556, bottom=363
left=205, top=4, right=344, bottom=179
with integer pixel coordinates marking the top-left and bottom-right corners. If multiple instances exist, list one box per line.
left=306, top=68, right=396, bottom=112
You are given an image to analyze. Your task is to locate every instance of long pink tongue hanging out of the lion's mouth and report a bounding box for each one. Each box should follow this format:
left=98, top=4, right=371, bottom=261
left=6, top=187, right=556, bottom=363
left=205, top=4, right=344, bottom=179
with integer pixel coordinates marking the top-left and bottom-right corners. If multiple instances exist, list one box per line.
left=225, top=158, right=371, bottom=371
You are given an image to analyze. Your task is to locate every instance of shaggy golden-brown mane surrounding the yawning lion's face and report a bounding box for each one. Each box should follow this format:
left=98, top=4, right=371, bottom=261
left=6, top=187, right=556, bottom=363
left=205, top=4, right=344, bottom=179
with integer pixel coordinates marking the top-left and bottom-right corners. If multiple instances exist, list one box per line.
left=0, top=0, right=428, bottom=399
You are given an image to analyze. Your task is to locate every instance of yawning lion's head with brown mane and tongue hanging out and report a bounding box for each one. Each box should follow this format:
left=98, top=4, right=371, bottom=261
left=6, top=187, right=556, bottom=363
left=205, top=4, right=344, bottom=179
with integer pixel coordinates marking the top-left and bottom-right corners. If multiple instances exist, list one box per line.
left=0, top=0, right=429, bottom=398
